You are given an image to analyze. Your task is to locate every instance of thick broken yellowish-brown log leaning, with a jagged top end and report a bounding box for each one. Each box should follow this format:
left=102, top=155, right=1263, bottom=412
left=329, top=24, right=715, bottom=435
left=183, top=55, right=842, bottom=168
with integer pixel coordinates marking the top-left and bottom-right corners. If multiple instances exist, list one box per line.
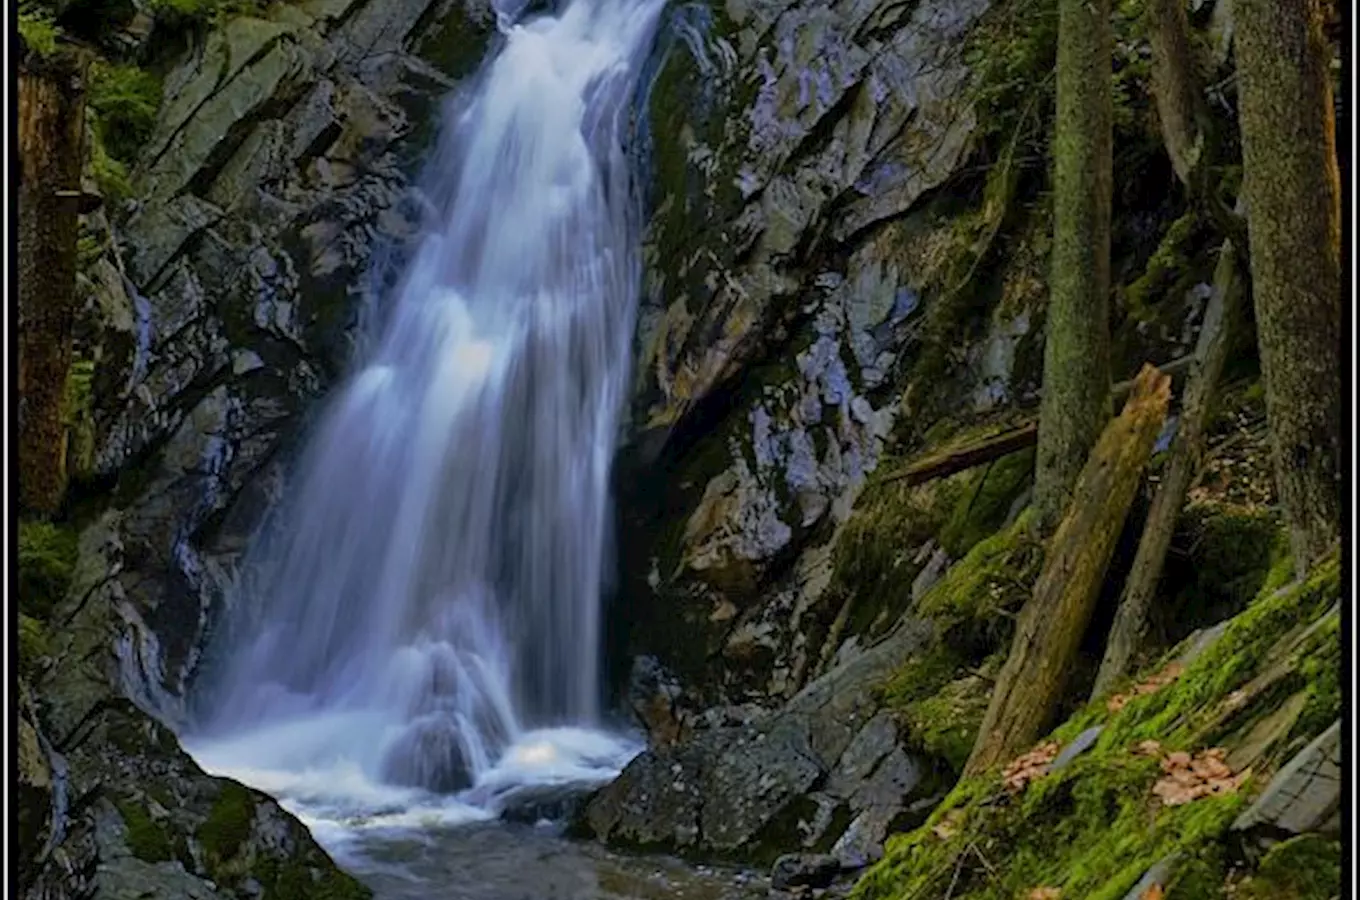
left=964, top=366, right=1171, bottom=776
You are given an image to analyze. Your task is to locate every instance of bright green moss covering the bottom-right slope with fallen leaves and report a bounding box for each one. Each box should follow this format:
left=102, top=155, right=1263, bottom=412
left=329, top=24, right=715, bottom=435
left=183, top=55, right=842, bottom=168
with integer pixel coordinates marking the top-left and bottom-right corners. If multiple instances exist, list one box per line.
left=855, top=559, right=1341, bottom=900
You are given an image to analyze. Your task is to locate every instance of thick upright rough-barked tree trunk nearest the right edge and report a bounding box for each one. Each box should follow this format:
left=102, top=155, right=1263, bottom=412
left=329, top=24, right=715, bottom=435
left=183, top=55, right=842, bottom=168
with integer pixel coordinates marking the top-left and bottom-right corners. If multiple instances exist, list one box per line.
left=1234, top=0, right=1342, bottom=572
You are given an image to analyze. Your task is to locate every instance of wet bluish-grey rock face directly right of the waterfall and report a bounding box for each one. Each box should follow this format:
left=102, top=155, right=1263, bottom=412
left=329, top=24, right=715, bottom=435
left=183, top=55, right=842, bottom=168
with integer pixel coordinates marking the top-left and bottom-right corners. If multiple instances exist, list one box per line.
left=616, top=0, right=990, bottom=704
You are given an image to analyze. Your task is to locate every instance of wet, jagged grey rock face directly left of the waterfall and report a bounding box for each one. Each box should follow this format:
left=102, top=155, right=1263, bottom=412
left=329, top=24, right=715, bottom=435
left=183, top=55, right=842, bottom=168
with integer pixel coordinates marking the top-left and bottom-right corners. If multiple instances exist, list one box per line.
left=71, top=0, right=492, bottom=722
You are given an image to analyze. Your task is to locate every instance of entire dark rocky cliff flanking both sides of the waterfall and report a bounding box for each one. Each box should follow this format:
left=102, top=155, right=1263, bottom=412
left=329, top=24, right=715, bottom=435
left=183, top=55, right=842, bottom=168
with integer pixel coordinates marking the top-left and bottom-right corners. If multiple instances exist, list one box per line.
left=20, top=0, right=1330, bottom=897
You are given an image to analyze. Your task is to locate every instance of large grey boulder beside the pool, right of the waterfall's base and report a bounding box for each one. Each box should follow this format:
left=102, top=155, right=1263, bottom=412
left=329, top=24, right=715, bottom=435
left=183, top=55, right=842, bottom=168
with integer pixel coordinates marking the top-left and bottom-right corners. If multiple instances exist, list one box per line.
left=582, top=623, right=929, bottom=861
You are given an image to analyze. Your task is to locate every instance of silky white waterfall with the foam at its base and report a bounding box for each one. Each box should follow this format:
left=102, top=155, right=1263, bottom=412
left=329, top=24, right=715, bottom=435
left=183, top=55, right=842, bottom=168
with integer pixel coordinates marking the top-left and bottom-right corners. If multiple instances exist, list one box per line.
left=186, top=0, right=662, bottom=846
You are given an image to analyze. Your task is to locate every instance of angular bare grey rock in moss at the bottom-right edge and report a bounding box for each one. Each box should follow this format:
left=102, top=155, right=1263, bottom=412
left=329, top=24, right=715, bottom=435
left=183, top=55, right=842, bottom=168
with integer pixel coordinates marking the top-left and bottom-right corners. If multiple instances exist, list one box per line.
left=1232, top=721, right=1341, bottom=833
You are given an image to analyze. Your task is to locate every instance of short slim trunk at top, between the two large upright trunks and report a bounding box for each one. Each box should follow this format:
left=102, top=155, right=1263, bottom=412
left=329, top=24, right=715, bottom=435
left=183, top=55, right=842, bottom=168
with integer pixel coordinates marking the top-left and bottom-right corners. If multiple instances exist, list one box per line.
left=1145, top=0, right=1205, bottom=185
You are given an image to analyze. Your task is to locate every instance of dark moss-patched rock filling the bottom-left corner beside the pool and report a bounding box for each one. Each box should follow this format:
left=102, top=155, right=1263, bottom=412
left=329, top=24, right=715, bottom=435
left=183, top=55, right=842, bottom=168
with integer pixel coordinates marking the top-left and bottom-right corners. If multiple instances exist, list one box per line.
left=22, top=522, right=369, bottom=900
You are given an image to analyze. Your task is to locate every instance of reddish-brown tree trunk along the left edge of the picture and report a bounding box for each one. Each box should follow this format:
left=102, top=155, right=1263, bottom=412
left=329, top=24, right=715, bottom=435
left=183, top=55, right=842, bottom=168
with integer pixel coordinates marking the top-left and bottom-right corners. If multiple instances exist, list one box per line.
left=18, top=52, right=87, bottom=515
